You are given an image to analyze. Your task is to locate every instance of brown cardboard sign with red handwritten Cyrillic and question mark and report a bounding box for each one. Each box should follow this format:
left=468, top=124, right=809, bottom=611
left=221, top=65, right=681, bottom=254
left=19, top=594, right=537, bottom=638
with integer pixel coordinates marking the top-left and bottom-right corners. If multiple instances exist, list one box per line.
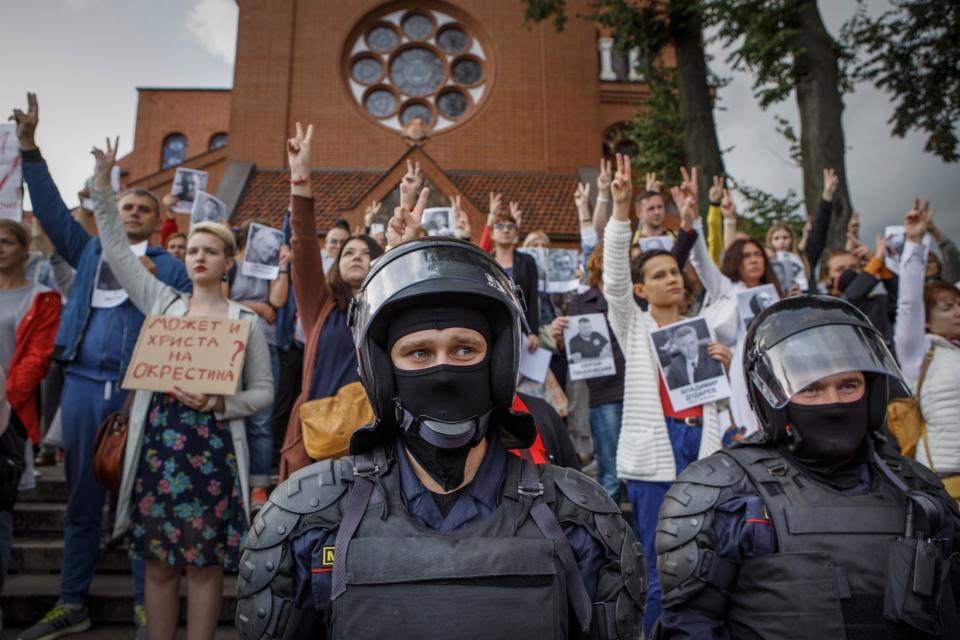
left=122, top=315, right=250, bottom=396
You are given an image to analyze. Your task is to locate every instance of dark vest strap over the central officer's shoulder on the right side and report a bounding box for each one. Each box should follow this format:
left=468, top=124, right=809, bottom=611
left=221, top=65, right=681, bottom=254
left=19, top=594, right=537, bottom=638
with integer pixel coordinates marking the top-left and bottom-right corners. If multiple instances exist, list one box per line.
left=517, top=459, right=593, bottom=633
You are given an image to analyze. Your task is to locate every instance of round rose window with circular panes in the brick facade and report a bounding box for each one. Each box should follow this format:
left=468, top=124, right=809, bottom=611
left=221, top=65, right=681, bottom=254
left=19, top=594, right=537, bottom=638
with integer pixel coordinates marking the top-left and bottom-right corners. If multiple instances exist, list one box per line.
left=345, top=7, right=492, bottom=131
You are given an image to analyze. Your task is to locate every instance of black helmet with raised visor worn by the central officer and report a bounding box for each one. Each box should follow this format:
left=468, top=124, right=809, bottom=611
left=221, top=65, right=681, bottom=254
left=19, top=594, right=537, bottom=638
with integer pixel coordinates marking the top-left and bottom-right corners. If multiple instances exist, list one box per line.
left=347, top=237, right=536, bottom=454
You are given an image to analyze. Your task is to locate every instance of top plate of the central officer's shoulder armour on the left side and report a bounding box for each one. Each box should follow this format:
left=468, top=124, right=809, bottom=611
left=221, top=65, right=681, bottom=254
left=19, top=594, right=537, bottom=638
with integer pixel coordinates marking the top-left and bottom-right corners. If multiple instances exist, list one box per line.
left=270, top=458, right=353, bottom=515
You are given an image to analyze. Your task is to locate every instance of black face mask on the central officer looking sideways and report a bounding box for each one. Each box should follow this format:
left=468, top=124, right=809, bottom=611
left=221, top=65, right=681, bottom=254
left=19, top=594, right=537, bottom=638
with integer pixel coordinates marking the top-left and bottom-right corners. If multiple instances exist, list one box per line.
left=394, top=359, right=493, bottom=491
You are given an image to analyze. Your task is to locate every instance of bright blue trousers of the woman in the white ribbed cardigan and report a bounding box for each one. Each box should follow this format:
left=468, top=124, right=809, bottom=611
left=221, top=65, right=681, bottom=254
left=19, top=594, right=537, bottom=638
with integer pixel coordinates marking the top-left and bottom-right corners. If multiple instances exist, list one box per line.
left=627, top=418, right=703, bottom=638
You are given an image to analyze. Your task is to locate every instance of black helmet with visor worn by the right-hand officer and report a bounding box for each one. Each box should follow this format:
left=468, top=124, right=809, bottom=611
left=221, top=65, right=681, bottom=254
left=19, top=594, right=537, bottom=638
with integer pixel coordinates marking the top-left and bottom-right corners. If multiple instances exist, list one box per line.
left=743, top=296, right=907, bottom=441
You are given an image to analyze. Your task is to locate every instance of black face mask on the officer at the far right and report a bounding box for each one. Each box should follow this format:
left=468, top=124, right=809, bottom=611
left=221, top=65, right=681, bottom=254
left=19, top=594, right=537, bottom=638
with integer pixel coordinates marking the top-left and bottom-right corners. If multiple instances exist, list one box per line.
left=787, top=395, right=869, bottom=478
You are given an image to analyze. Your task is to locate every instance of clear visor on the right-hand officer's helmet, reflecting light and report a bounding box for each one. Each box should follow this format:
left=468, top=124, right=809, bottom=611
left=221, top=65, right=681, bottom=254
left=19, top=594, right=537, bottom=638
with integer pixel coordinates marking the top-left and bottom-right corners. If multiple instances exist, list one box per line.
left=750, top=324, right=903, bottom=409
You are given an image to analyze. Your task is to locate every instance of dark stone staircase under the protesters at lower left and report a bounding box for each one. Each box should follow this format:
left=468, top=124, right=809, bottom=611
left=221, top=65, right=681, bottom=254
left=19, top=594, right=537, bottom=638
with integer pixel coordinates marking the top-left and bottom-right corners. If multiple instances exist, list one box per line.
left=0, top=465, right=236, bottom=640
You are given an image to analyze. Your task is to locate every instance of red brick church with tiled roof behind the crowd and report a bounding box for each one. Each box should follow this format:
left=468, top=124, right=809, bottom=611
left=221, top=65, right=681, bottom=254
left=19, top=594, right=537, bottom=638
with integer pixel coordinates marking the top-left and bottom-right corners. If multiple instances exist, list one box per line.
left=114, top=0, right=660, bottom=242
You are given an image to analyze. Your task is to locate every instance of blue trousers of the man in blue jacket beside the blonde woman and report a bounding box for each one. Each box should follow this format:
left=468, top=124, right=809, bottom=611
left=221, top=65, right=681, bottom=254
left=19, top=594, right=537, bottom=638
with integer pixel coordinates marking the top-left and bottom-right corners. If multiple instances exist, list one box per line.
left=60, top=371, right=144, bottom=604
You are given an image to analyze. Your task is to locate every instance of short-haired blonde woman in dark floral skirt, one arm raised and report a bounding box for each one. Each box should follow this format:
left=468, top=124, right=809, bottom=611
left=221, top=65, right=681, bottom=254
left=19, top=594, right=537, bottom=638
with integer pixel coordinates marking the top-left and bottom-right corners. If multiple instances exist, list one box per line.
left=93, top=141, right=273, bottom=640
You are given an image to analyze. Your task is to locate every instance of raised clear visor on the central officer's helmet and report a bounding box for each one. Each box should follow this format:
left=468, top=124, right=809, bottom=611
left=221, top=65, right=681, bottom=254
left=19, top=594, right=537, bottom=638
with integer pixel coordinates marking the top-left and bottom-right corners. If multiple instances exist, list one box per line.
left=351, top=243, right=523, bottom=344
